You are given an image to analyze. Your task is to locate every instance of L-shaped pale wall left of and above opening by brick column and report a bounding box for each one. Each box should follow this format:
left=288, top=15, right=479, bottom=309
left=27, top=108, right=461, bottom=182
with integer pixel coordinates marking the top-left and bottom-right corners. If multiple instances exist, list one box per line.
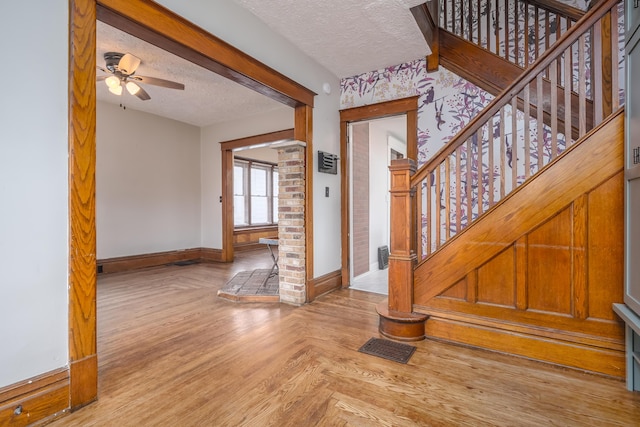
left=200, top=106, right=294, bottom=249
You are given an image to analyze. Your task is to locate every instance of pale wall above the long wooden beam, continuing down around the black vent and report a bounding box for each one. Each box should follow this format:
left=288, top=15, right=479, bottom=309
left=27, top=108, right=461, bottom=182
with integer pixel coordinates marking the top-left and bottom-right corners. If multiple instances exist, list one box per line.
left=158, top=0, right=341, bottom=277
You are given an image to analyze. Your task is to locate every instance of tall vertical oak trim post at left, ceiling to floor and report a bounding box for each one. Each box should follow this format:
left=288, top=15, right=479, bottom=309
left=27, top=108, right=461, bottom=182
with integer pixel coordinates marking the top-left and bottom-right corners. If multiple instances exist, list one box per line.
left=69, top=0, right=98, bottom=414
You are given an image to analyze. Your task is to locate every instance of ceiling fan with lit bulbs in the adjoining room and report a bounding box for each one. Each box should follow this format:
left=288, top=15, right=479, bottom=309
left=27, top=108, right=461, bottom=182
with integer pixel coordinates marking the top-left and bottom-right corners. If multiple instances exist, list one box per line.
left=97, top=52, right=184, bottom=101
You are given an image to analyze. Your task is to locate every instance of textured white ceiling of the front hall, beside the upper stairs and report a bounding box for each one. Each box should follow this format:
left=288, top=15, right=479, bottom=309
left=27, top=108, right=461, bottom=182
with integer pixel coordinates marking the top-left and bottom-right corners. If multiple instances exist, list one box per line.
left=234, top=0, right=431, bottom=78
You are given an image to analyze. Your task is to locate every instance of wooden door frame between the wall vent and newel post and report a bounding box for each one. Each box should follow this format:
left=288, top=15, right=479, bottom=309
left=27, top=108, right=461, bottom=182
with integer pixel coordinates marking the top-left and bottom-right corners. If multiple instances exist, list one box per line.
left=340, top=96, right=419, bottom=287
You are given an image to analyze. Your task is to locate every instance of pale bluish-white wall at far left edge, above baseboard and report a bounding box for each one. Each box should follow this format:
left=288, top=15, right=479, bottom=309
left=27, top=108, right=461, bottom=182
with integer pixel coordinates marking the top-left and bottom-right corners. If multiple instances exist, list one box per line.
left=0, top=0, right=69, bottom=387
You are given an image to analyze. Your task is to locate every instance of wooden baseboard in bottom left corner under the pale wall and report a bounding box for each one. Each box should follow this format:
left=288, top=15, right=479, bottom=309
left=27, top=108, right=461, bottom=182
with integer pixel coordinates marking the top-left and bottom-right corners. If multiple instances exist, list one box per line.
left=0, top=368, right=69, bottom=426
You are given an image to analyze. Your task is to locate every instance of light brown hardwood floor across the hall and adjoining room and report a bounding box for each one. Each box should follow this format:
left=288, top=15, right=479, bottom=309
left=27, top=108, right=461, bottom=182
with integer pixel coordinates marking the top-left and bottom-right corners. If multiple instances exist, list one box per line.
left=50, top=252, right=640, bottom=427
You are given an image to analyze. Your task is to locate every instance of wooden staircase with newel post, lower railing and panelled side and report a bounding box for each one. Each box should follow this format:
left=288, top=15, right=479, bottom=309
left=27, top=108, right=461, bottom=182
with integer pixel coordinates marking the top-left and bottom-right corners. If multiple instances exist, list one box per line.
left=378, top=0, right=624, bottom=377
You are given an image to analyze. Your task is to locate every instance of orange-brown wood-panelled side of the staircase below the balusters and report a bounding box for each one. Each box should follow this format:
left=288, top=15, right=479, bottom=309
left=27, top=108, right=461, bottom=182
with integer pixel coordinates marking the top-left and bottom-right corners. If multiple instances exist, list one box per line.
left=413, top=113, right=625, bottom=377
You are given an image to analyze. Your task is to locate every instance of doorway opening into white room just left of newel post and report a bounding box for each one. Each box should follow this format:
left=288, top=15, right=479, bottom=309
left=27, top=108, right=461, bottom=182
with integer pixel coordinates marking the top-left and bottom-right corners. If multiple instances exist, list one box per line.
left=348, top=114, right=407, bottom=295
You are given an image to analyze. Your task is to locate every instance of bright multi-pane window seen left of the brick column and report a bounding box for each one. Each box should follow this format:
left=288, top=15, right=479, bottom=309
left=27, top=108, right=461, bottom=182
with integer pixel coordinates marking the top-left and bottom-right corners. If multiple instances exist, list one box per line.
left=233, top=157, right=278, bottom=227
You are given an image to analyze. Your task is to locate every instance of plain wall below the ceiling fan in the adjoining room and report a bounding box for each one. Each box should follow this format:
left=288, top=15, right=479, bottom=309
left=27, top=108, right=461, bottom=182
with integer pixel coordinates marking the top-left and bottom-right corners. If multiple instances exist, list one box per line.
left=96, top=102, right=200, bottom=259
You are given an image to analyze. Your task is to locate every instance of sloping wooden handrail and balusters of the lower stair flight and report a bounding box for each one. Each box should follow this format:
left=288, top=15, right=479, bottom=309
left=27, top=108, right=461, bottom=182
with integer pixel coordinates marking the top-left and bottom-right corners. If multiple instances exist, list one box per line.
left=408, top=0, right=623, bottom=262
